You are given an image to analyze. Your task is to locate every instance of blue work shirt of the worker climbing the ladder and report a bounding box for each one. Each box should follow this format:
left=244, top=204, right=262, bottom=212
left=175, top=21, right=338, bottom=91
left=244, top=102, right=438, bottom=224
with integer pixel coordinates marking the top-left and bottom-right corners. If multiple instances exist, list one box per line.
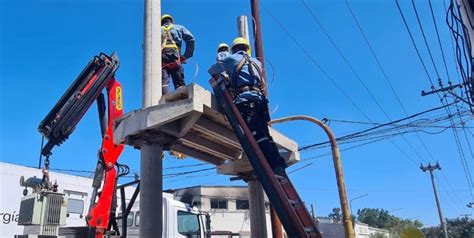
left=208, top=51, right=262, bottom=103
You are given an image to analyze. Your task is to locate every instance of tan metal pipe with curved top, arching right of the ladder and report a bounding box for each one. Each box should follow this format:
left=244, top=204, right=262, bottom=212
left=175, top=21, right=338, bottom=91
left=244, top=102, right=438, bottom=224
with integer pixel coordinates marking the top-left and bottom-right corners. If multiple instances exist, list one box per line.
left=270, top=115, right=355, bottom=238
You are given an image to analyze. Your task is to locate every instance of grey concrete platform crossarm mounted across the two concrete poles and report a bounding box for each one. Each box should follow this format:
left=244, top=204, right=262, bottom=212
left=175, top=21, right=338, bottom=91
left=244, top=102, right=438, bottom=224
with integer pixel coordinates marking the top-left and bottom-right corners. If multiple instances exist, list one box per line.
left=114, top=84, right=299, bottom=174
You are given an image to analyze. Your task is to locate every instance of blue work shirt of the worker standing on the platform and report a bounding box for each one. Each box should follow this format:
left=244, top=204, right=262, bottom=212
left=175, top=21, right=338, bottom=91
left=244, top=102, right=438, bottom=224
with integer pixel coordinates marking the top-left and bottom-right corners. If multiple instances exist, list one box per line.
left=161, top=22, right=195, bottom=58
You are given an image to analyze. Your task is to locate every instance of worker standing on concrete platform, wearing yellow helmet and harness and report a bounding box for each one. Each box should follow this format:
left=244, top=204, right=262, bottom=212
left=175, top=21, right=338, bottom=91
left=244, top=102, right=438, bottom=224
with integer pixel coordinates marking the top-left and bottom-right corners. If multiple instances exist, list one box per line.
left=161, top=14, right=195, bottom=95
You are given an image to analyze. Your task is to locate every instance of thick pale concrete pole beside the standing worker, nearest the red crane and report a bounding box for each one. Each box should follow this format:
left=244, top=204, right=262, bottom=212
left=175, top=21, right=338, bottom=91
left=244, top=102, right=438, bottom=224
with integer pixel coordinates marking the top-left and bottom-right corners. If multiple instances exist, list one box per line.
left=139, top=0, right=163, bottom=238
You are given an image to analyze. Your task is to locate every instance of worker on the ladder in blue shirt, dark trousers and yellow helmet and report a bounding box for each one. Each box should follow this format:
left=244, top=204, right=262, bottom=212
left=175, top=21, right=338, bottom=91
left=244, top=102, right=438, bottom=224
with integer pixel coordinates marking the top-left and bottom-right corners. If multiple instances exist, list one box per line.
left=208, top=37, right=286, bottom=176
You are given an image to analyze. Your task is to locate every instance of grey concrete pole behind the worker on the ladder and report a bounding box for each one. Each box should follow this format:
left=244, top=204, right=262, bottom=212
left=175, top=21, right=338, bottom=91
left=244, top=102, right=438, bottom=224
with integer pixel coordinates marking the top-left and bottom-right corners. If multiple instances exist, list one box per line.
left=237, top=16, right=268, bottom=238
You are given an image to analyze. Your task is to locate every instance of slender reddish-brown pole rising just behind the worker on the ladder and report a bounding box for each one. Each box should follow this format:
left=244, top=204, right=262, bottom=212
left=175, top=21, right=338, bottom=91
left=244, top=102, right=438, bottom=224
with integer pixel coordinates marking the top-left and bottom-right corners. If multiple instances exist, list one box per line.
left=250, top=0, right=283, bottom=238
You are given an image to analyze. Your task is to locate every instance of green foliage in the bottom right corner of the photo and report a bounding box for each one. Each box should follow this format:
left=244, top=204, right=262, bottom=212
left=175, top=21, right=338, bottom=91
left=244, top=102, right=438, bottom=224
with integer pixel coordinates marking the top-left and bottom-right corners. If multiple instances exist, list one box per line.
left=423, top=218, right=474, bottom=238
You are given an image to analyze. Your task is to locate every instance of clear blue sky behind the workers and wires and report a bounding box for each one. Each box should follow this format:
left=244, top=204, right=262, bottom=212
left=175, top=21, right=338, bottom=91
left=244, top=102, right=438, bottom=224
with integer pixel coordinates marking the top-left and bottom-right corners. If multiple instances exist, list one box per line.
left=0, top=0, right=474, bottom=225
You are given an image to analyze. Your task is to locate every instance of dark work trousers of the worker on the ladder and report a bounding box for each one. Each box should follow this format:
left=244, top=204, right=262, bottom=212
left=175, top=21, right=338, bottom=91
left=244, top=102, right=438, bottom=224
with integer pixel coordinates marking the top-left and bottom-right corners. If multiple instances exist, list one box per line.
left=236, top=99, right=286, bottom=169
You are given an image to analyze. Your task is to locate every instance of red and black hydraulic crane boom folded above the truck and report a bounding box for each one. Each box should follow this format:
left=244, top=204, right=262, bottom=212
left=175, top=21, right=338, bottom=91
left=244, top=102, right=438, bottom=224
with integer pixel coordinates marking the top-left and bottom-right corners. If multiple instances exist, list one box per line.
left=38, top=53, right=123, bottom=238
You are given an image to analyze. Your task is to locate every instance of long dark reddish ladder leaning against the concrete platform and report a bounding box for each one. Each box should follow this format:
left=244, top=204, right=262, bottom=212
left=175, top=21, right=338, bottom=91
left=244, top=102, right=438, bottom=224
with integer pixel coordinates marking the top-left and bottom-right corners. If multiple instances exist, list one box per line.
left=209, top=77, right=321, bottom=238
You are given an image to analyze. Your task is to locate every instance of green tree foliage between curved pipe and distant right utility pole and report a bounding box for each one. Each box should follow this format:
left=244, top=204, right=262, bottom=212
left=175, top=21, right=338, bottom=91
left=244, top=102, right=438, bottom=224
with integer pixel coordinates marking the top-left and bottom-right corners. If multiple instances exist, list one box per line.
left=357, top=208, right=423, bottom=235
